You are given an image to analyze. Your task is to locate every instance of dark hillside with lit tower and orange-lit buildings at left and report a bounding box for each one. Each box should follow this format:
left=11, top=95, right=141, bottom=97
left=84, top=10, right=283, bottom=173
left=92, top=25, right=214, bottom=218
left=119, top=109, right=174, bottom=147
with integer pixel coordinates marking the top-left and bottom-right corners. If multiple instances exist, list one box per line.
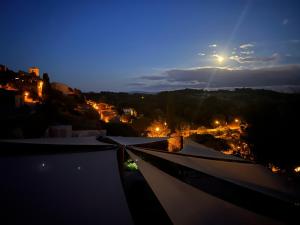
left=0, top=65, right=104, bottom=138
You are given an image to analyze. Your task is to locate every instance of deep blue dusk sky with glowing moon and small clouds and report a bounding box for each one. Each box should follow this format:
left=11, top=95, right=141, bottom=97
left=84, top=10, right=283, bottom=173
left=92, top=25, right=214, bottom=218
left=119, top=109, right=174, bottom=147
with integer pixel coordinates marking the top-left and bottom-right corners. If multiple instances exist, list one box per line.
left=0, top=0, right=300, bottom=91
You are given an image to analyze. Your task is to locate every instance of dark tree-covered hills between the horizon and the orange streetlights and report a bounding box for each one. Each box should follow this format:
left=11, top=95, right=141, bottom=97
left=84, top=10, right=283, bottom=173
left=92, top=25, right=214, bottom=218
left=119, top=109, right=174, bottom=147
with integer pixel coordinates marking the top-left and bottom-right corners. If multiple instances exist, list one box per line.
left=85, top=89, right=300, bottom=170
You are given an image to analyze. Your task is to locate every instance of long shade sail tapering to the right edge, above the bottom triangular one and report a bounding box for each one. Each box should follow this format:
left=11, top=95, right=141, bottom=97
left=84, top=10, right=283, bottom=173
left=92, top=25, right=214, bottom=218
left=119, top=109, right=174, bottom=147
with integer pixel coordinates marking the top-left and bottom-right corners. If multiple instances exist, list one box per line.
left=135, top=148, right=299, bottom=200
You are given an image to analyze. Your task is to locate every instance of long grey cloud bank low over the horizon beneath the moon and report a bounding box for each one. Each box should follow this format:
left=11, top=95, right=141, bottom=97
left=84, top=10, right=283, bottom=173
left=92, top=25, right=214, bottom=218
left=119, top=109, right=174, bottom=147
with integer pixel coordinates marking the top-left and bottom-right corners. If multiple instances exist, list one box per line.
left=135, top=64, right=300, bottom=90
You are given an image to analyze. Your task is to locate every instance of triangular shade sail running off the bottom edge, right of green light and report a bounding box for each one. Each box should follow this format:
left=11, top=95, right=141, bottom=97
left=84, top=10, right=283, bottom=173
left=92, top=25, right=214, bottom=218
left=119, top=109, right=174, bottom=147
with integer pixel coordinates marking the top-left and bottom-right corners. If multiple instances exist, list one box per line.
left=128, top=151, right=280, bottom=225
